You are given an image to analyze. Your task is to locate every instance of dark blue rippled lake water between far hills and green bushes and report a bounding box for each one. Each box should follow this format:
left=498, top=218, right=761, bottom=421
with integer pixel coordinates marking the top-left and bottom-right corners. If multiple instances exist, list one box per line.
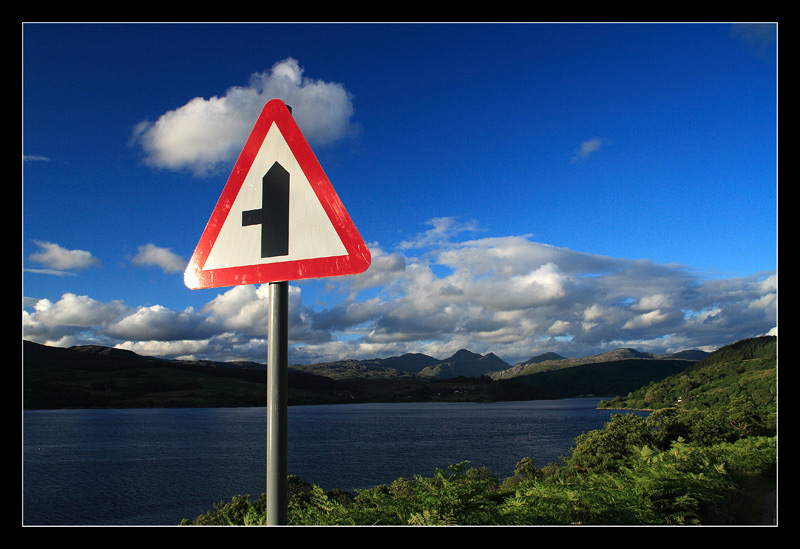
left=23, top=398, right=648, bottom=525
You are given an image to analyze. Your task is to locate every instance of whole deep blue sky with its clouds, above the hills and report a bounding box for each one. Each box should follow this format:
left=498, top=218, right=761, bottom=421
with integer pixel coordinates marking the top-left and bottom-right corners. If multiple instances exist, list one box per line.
left=22, top=23, right=778, bottom=364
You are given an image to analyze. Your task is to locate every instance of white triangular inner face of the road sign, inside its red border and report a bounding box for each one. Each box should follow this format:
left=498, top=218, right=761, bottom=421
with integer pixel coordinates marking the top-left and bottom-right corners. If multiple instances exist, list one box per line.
left=203, top=123, right=347, bottom=270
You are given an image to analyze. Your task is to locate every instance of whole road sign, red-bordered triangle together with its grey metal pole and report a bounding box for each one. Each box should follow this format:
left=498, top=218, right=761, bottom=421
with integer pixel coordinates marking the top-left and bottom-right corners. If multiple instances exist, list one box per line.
left=183, top=99, right=372, bottom=525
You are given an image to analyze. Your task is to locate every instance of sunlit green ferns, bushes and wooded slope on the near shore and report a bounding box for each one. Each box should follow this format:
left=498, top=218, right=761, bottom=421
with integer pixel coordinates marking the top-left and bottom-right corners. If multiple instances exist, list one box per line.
left=182, top=338, right=777, bottom=525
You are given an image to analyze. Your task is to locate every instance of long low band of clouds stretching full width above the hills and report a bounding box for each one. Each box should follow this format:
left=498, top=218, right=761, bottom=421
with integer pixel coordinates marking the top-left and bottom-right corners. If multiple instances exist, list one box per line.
left=23, top=219, right=777, bottom=364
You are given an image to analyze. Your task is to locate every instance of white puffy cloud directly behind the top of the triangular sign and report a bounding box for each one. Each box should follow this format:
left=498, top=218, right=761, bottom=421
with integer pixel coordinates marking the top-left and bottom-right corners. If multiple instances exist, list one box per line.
left=132, top=58, right=355, bottom=175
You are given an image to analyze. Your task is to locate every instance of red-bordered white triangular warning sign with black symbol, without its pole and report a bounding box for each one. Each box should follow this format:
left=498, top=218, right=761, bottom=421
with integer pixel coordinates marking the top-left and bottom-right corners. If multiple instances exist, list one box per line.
left=184, top=99, right=371, bottom=289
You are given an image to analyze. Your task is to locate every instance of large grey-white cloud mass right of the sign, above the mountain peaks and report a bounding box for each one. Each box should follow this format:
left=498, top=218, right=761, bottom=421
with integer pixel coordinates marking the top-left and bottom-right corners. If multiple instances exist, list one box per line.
left=306, top=222, right=777, bottom=361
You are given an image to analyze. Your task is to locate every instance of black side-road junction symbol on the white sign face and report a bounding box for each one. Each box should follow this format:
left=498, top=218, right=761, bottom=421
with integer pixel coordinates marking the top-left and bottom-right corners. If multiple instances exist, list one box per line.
left=242, top=162, right=289, bottom=258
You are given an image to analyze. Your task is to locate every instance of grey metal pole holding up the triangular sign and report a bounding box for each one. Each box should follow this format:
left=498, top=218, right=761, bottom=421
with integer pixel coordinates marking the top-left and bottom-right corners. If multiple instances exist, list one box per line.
left=267, top=282, right=289, bottom=525
